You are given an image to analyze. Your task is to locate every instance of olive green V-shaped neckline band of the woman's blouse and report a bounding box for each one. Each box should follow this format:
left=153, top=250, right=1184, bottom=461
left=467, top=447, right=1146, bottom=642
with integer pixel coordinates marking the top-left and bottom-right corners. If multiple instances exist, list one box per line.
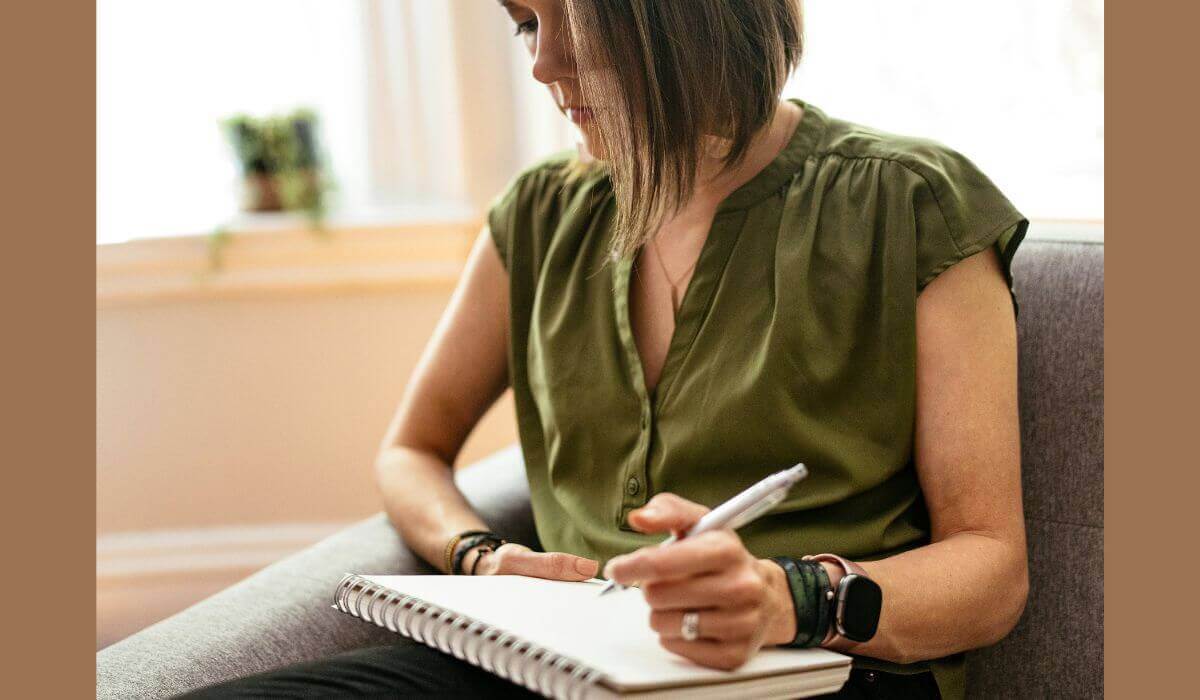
left=613, top=98, right=826, bottom=421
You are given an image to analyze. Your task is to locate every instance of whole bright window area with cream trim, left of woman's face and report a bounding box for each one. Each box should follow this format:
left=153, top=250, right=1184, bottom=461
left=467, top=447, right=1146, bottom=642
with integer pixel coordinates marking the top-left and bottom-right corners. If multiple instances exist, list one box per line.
left=96, top=0, right=572, bottom=243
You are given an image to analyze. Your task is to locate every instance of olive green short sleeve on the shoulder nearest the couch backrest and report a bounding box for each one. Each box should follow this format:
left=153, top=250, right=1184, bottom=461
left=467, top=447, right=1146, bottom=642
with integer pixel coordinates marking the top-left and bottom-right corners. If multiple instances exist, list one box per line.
left=902, top=142, right=1030, bottom=304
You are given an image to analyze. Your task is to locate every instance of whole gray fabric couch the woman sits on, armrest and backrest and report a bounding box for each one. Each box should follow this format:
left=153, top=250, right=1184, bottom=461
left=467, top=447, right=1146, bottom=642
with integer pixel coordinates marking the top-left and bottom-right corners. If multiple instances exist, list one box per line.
left=96, top=240, right=1104, bottom=699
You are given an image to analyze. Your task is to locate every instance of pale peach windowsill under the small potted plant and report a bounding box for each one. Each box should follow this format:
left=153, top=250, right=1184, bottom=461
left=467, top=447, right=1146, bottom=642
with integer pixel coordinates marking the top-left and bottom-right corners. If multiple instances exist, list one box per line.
left=96, top=208, right=481, bottom=307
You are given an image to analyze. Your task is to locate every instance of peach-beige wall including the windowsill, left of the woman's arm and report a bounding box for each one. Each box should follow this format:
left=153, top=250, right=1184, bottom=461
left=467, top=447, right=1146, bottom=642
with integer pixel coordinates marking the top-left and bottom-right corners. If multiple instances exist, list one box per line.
left=96, top=225, right=516, bottom=646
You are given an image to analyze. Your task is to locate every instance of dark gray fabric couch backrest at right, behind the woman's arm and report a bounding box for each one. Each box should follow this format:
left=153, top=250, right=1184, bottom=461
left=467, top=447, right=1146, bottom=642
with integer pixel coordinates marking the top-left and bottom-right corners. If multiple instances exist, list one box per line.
left=967, top=240, right=1104, bottom=698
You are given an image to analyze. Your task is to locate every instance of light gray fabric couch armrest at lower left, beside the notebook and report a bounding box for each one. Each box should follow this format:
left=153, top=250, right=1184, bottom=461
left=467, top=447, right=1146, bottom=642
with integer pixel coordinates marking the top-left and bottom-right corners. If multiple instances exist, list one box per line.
left=96, top=445, right=539, bottom=699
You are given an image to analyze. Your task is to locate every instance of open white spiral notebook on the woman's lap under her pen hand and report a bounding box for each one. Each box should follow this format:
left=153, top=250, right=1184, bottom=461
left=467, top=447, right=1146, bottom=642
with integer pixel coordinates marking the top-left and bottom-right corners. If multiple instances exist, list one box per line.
left=334, top=574, right=851, bottom=699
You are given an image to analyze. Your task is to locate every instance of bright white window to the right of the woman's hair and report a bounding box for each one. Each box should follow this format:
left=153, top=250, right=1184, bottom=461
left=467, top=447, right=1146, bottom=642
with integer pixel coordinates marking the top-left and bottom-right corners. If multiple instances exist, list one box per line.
left=785, top=0, right=1104, bottom=221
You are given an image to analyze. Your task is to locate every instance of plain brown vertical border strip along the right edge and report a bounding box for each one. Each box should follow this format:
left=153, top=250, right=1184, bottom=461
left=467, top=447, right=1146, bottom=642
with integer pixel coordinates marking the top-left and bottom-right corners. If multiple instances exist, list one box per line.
left=1104, top=1, right=1200, bottom=698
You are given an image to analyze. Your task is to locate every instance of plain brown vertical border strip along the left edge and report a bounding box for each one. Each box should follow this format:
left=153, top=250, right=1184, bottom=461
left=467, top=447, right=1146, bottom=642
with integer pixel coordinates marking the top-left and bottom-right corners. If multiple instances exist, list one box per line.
left=0, top=2, right=96, bottom=698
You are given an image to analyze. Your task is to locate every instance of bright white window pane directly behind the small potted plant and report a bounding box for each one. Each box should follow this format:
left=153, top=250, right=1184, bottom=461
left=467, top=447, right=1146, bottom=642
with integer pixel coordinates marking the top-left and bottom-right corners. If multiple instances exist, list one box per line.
left=96, top=0, right=366, bottom=243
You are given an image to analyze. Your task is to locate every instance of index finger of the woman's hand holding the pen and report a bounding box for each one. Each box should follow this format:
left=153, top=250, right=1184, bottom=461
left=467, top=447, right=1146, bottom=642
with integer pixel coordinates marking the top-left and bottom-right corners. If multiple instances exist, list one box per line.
left=605, top=530, right=746, bottom=585
